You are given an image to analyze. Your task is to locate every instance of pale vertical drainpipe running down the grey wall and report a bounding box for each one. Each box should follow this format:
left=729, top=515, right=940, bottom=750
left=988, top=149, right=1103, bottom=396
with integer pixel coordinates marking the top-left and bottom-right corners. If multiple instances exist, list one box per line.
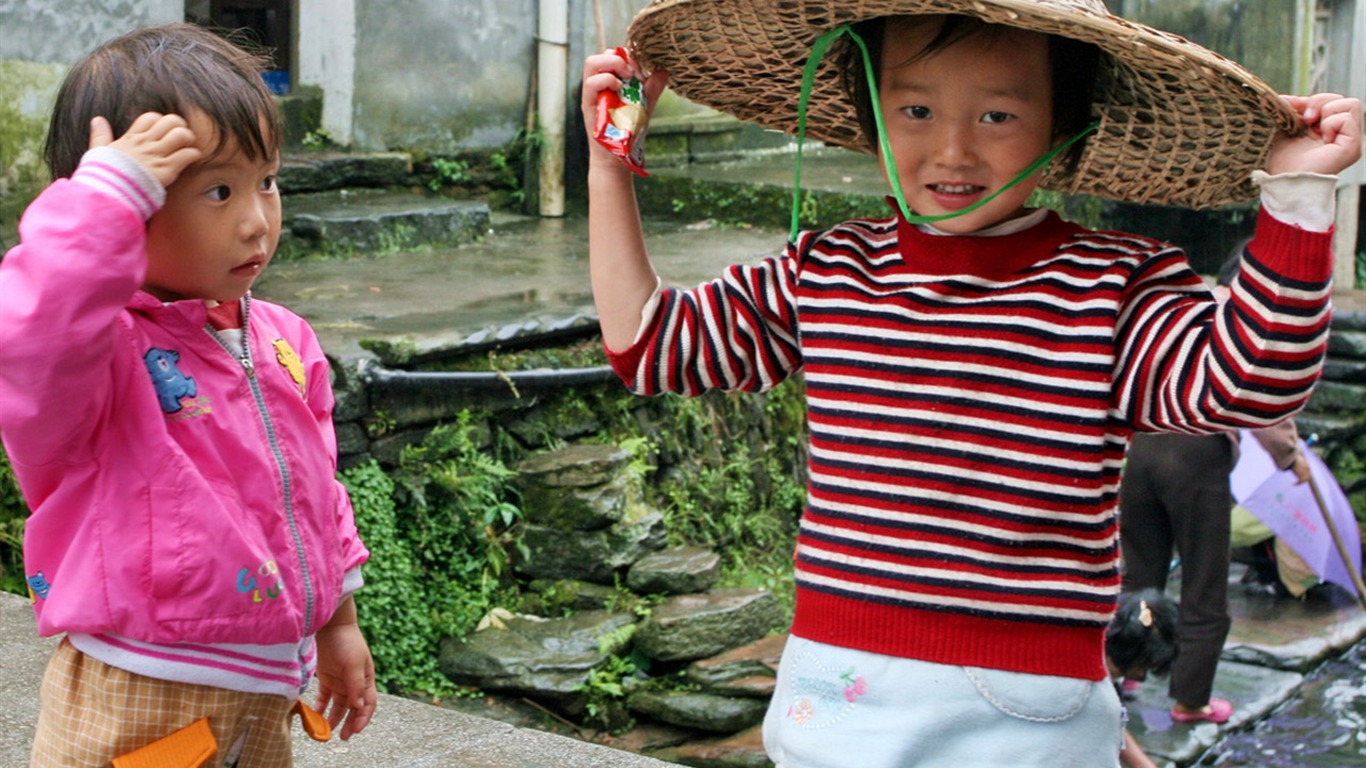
left=535, top=0, right=570, bottom=216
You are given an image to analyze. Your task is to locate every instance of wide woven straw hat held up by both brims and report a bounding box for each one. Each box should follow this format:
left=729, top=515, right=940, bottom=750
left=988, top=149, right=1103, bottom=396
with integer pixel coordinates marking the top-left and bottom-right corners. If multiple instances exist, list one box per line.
left=627, top=0, right=1303, bottom=208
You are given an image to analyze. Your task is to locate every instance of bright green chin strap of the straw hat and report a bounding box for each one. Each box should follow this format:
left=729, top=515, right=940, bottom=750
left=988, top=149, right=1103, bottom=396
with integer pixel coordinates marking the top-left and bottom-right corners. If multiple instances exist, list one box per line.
left=788, top=25, right=1100, bottom=242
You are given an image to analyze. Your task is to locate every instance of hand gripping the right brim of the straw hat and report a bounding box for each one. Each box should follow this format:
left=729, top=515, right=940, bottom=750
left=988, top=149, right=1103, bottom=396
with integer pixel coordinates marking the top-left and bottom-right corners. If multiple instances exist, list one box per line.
left=1266, top=93, right=1362, bottom=175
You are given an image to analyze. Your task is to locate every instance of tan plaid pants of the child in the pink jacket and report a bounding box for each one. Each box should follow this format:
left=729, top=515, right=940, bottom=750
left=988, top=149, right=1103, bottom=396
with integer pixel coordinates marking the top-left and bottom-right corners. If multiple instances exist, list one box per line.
left=30, top=640, right=294, bottom=768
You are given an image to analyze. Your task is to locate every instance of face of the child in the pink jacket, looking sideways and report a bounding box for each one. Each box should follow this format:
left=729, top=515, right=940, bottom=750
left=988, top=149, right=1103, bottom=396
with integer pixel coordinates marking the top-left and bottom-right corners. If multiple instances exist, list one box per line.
left=142, top=112, right=280, bottom=302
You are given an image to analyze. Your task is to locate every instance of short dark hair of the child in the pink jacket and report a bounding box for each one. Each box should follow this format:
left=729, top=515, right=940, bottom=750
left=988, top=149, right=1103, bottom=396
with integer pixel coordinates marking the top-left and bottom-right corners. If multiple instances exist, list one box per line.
left=42, top=23, right=283, bottom=179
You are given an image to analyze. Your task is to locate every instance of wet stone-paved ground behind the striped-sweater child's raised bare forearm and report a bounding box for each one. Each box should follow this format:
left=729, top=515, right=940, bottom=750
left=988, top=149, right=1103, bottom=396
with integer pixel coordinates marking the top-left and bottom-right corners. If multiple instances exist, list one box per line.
left=254, top=206, right=787, bottom=354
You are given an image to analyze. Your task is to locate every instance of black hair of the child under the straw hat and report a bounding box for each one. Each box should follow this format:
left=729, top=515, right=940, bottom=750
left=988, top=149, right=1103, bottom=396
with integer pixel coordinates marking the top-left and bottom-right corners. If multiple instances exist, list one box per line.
left=837, top=15, right=1101, bottom=171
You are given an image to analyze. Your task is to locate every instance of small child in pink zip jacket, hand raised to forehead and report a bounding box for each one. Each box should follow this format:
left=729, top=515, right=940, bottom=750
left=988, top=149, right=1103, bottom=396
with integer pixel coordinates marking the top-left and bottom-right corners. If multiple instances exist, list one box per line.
left=0, top=25, right=376, bottom=767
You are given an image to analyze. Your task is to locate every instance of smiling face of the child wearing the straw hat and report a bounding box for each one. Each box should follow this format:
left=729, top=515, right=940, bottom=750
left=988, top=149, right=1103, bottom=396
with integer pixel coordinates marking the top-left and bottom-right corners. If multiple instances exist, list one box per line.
left=880, top=18, right=1053, bottom=234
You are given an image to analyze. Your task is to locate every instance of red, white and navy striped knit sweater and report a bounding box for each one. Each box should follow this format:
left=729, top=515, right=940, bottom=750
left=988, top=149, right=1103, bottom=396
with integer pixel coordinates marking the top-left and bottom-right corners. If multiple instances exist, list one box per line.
left=609, top=204, right=1332, bottom=681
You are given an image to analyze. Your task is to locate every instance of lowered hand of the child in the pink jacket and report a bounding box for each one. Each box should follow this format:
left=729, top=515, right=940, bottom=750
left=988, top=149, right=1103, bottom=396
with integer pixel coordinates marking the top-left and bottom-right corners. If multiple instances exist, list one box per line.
left=313, top=599, right=380, bottom=741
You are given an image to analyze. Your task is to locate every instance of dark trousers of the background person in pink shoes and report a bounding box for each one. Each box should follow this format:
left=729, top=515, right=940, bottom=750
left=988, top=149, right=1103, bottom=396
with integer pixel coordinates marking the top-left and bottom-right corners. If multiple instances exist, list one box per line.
left=1120, top=433, right=1233, bottom=707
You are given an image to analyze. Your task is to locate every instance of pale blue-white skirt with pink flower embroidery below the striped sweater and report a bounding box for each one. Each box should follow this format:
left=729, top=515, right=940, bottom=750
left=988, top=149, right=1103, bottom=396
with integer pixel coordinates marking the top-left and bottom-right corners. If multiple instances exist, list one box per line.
left=764, top=637, right=1124, bottom=768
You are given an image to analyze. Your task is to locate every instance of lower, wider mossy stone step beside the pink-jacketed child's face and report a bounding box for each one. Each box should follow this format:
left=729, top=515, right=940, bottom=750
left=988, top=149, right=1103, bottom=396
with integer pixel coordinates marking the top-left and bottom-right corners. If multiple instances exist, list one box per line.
left=276, top=189, right=489, bottom=260
